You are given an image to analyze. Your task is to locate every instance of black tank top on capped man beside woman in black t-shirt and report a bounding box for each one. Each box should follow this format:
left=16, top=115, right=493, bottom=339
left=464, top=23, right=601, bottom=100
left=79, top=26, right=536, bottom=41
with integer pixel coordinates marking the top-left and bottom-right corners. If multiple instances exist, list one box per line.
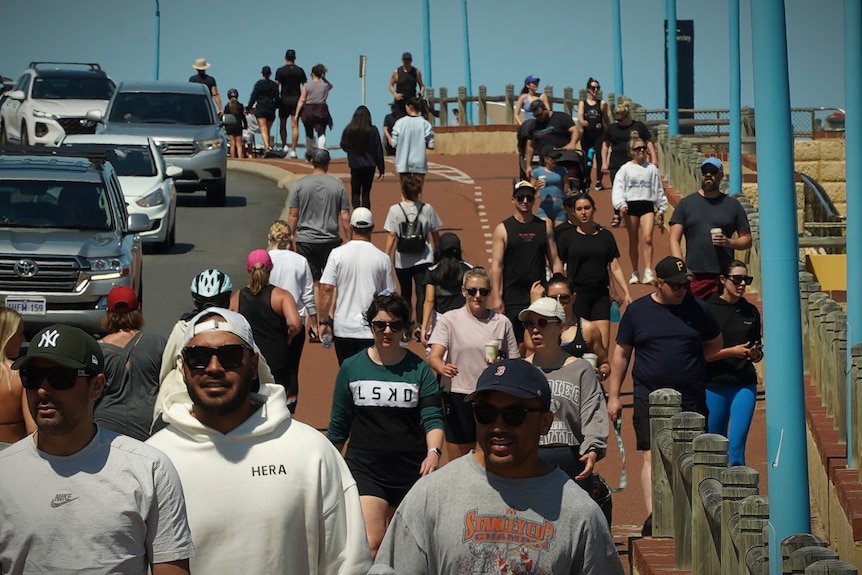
left=503, top=216, right=548, bottom=307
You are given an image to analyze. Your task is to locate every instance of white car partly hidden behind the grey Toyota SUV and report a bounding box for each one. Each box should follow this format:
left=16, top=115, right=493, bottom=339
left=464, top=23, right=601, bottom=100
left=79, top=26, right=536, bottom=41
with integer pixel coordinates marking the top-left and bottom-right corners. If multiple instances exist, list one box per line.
left=63, top=134, right=183, bottom=252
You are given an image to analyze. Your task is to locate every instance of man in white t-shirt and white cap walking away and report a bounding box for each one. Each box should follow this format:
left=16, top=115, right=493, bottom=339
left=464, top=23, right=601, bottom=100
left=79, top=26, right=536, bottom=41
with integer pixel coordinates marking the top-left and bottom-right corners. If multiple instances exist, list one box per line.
left=318, top=208, right=395, bottom=365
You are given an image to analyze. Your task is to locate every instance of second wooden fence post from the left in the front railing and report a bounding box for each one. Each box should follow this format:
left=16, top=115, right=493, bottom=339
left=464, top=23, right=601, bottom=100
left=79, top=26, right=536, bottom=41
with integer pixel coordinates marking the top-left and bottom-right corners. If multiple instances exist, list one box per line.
left=671, top=411, right=706, bottom=569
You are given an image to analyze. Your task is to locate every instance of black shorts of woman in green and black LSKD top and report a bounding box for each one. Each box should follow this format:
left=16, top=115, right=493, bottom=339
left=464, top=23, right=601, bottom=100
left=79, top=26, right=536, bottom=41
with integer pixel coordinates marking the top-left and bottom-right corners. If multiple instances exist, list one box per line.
left=344, top=445, right=426, bottom=507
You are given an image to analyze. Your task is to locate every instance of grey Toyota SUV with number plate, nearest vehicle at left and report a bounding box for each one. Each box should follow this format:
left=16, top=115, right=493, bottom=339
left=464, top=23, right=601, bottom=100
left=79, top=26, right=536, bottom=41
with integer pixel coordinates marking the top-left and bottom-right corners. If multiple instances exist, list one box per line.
left=0, top=148, right=149, bottom=333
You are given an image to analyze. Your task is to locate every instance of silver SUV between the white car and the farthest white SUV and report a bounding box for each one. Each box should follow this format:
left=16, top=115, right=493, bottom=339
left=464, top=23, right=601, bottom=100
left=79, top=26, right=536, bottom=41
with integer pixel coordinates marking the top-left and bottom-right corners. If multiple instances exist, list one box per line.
left=87, top=82, right=227, bottom=206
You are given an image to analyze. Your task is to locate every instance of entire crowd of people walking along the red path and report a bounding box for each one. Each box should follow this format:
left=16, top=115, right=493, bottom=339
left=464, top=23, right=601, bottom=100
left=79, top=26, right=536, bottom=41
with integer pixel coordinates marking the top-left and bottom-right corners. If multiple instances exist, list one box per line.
left=0, top=50, right=763, bottom=575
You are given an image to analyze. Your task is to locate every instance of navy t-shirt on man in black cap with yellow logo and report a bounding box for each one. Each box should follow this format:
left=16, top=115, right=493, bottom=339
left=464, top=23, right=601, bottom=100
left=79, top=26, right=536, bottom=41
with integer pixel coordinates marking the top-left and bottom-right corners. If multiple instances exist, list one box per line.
left=617, top=293, right=721, bottom=403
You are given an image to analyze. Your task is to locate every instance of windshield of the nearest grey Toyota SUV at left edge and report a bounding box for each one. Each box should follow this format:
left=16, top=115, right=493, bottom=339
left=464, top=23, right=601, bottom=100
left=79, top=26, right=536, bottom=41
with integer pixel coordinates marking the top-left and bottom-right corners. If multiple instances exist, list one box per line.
left=0, top=180, right=113, bottom=231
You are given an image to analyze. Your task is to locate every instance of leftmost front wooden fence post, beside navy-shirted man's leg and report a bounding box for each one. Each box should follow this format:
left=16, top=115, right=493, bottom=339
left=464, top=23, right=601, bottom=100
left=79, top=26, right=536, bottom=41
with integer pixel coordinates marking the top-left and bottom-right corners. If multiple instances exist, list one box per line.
left=649, top=389, right=682, bottom=537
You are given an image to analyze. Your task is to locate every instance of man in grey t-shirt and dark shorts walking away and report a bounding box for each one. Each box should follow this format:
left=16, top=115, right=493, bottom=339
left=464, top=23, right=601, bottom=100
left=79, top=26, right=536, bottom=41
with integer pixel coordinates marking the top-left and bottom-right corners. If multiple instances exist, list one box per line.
left=287, top=148, right=351, bottom=301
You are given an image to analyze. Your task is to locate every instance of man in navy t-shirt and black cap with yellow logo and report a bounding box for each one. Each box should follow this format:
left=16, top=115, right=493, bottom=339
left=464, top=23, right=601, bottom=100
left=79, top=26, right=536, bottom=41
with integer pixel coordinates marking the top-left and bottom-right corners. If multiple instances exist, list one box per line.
left=607, top=256, right=722, bottom=535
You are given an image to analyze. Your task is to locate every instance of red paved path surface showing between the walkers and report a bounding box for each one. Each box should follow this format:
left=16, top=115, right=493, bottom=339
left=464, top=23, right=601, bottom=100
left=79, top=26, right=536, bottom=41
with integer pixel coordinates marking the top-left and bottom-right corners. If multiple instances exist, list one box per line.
left=255, top=154, right=767, bottom=572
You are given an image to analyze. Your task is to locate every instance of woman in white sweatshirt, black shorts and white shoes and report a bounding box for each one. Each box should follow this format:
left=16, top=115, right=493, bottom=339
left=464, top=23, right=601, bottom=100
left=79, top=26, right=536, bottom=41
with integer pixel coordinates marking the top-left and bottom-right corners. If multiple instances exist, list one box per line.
left=611, top=136, right=667, bottom=284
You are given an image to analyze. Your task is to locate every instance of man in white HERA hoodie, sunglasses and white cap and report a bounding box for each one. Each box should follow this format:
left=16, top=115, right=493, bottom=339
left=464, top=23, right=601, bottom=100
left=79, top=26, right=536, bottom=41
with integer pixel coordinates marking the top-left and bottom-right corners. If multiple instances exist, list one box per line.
left=148, top=308, right=371, bottom=575
